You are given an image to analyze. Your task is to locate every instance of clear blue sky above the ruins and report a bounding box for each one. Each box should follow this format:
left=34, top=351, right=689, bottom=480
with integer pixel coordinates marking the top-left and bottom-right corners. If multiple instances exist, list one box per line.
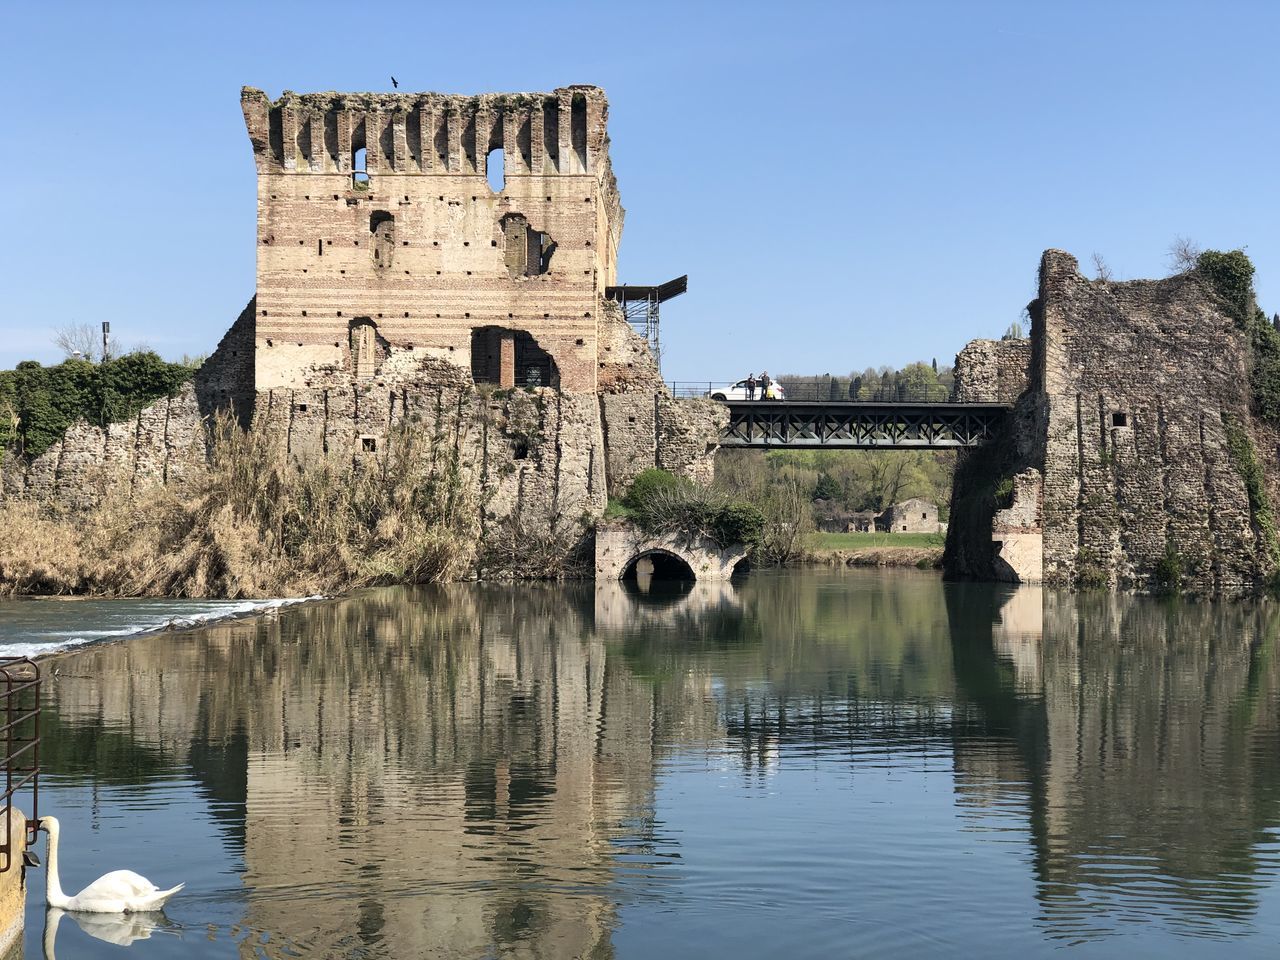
left=0, top=0, right=1280, bottom=379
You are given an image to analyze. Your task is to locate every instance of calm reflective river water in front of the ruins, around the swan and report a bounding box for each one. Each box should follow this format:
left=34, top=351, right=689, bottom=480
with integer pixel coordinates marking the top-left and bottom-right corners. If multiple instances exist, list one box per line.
left=10, top=571, right=1280, bottom=960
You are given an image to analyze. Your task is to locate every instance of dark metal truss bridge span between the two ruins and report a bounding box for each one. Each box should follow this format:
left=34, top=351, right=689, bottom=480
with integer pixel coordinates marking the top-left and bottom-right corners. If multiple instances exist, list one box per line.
left=721, top=401, right=1009, bottom=449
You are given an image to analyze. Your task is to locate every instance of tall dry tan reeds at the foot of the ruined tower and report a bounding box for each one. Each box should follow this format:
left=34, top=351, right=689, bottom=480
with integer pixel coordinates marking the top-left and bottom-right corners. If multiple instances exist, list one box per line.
left=0, top=421, right=477, bottom=598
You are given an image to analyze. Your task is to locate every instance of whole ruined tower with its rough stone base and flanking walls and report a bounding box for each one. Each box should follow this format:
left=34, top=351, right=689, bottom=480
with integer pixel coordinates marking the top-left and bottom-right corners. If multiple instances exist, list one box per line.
left=0, top=86, right=726, bottom=570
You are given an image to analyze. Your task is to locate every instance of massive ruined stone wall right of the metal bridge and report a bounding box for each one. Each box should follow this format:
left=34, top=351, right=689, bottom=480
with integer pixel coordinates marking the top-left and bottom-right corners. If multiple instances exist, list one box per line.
left=947, top=250, right=1270, bottom=594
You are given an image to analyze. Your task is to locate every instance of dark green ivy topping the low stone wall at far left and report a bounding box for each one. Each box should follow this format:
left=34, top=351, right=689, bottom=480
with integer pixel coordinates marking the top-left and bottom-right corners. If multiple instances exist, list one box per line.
left=0, top=351, right=196, bottom=458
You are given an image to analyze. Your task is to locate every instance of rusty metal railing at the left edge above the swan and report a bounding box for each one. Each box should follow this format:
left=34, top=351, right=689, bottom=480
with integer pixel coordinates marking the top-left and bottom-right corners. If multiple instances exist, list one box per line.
left=0, top=657, right=40, bottom=873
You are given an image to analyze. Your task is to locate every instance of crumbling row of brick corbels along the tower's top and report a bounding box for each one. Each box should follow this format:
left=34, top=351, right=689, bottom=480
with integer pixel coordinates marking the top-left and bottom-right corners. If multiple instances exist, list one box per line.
left=241, top=86, right=612, bottom=180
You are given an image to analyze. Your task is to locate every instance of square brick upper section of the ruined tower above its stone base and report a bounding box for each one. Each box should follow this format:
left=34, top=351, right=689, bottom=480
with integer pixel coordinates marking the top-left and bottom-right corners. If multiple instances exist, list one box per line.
left=241, top=86, right=623, bottom=394
